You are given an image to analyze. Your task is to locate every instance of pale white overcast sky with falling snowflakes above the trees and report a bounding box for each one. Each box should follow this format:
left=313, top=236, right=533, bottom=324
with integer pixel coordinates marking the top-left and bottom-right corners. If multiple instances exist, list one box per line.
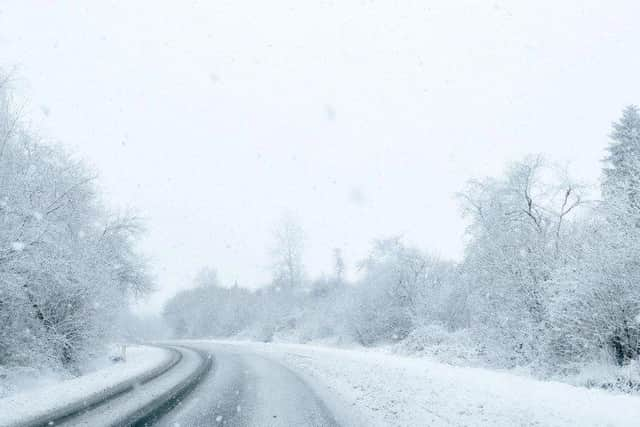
left=0, top=0, right=640, bottom=310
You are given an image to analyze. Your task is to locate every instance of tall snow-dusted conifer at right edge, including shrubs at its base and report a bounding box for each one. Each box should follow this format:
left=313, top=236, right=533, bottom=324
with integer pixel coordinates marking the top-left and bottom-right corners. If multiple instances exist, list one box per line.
left=552, top=106, right=640, bottom=365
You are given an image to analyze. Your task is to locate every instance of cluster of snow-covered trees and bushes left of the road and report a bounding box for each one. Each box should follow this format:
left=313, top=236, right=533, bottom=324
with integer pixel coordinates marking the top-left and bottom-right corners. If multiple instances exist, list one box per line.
left=0, top=74, right=150, bottom=371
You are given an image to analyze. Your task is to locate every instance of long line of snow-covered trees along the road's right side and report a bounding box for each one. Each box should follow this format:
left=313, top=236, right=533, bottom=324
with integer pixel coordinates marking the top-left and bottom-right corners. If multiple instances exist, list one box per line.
left=165, top=106, right=640, bottom=378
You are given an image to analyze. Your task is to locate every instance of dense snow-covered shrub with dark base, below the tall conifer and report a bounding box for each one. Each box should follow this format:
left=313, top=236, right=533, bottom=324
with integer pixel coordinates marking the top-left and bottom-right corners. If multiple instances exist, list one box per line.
left=548, top=217, right=640, bottom=372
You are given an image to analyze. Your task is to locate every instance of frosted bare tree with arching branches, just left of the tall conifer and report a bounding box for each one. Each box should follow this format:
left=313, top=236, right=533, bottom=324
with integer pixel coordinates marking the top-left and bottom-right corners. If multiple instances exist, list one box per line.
left=461, top=156, right=584, bottom=365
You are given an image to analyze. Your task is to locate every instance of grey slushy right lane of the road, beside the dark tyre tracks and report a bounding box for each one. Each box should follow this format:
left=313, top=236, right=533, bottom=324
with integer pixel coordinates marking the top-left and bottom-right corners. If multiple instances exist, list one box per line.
left=154, top=343, right=338, bottom=427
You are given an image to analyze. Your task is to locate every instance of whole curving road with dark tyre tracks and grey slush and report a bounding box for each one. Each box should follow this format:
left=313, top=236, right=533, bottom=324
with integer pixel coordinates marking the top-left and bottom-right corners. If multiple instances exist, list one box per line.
left=7, top=341, right=342, bottom=427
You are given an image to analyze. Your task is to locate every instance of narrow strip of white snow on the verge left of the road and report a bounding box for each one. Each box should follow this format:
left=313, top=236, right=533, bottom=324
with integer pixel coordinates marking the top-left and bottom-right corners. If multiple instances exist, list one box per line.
left=0, top=346, right=171, bottom=426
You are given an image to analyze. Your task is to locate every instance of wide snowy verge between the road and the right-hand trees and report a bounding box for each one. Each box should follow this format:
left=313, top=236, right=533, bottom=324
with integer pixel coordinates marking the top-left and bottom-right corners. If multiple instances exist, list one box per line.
left=214, top=342, right=640, bottom=427
